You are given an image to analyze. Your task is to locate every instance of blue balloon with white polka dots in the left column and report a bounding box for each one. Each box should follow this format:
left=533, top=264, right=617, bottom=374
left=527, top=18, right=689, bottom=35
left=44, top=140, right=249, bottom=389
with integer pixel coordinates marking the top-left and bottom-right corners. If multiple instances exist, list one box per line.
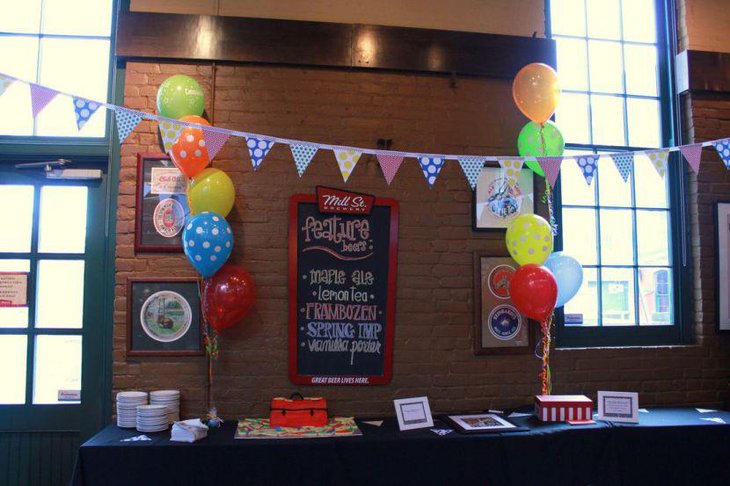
left=183, top=211, right=233, bottom=278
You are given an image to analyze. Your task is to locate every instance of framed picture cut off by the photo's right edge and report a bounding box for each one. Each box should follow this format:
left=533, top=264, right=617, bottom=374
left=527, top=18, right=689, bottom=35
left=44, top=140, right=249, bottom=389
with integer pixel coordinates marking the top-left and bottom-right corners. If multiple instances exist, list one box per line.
left=715, top=202, right=730, bottom=333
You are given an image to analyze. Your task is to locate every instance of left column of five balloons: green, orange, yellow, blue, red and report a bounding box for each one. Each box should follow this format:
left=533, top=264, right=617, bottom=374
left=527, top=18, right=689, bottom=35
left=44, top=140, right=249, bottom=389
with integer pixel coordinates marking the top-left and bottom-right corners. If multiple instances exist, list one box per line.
left=157, top=74, right=256, bottom=334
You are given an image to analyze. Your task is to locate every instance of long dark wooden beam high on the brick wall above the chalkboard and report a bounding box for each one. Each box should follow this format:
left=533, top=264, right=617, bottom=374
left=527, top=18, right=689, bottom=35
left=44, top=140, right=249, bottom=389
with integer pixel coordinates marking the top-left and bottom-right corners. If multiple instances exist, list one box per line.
left=116, top=12, right=555, bottom=78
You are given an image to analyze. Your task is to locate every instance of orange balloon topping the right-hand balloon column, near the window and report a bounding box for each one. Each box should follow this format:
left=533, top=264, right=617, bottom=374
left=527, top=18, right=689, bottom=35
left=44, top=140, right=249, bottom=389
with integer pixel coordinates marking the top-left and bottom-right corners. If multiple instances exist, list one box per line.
left=512, top=62, right=560, bottom=124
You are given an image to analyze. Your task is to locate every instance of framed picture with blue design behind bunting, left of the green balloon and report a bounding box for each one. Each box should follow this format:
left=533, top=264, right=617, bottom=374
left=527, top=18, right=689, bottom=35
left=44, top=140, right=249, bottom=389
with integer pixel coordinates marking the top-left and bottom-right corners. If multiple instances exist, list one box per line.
left=472, top=167, right=535, bottom=231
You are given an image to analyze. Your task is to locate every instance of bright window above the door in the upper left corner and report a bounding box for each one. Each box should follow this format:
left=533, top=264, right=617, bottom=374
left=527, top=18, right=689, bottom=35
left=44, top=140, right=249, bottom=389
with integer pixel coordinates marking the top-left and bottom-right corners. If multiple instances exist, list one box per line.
left=0, top=0, right=112, bottom=138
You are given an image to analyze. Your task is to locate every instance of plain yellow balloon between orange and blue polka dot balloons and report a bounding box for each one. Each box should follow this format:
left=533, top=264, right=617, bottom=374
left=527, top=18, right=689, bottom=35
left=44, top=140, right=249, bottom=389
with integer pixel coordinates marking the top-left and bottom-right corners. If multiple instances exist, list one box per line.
left=187, top=167, right=236, bottom=218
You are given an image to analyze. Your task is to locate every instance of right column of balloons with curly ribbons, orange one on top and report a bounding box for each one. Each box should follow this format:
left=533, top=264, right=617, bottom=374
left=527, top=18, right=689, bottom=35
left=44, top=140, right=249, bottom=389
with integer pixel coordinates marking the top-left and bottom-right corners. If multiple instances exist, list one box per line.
left=505, top=63, right=583, bottom=395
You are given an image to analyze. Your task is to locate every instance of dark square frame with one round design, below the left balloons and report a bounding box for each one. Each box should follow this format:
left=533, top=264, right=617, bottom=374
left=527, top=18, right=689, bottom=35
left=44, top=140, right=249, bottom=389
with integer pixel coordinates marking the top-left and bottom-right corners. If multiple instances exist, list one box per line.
left=127, top=278, right=203, bottom=356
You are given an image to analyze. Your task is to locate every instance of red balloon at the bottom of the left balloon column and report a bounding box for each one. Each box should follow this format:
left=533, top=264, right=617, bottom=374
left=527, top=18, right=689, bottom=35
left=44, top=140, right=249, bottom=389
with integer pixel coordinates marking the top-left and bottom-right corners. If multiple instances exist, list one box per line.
left=203, top=263, right=256, bottom=331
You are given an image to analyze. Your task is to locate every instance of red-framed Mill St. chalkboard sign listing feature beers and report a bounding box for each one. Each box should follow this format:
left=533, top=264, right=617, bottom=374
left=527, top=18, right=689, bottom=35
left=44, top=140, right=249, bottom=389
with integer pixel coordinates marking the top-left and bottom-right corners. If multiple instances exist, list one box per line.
left=289, top=188, right=399, bottom=385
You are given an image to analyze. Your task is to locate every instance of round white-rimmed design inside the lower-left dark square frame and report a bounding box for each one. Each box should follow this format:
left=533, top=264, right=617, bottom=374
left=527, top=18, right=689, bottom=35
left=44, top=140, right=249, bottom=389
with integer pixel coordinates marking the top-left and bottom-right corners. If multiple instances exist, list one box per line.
left=139, top=290, right=193, bottom=343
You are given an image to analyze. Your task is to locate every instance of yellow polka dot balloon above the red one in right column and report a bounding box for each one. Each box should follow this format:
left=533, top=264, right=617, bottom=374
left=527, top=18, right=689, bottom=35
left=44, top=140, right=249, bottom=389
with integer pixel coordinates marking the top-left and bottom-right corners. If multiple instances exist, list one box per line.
left=505, top=214, right=553, bottom=265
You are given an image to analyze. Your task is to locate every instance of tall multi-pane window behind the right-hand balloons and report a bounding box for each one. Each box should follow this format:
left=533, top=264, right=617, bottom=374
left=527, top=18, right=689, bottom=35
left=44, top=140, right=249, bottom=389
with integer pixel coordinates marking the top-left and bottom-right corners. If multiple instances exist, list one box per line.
left=549, top=0, right=681, bottom=345
